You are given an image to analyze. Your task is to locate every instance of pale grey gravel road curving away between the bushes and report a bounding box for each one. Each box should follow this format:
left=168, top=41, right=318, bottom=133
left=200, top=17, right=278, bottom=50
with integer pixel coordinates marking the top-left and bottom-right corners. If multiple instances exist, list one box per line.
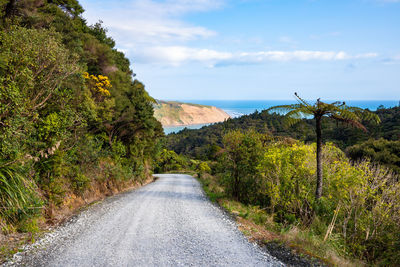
left=5, top=174, right=283, bottom=266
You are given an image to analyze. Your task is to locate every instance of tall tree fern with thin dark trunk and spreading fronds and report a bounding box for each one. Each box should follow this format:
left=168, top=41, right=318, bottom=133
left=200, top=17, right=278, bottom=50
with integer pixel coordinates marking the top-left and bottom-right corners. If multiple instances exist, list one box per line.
left=267, top=93, right=380, bottom=199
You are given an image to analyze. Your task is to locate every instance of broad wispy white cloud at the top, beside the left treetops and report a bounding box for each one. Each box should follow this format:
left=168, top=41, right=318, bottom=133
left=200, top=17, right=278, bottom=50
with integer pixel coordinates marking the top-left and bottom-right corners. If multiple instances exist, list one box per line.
left=82, top=0, right=224, bottom=45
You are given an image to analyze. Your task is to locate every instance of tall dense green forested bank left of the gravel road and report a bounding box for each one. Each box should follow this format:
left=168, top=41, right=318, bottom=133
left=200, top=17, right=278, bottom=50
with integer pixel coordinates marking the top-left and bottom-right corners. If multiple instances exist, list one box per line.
left=0, top=0, right=163, bottom=238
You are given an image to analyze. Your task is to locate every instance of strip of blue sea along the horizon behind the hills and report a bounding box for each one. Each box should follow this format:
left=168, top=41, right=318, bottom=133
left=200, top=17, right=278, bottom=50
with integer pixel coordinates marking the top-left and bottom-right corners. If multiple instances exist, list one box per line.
left=164, top=100, right=400, bottom=134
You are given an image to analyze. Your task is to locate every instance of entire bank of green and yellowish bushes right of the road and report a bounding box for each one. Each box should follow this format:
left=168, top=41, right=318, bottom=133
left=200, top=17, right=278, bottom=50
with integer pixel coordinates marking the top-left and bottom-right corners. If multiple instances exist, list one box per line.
left=212, top=131, right=400, bottom=265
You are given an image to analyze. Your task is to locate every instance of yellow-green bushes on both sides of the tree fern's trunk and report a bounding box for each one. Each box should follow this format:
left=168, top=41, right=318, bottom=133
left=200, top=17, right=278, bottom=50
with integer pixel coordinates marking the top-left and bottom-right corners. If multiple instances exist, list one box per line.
left=258, top=142, right=400, bottom=264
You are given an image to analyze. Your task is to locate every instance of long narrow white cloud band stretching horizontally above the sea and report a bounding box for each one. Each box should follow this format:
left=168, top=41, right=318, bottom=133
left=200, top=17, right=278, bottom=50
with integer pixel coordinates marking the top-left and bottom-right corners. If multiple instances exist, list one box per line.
left=136, top=46, right=378, bottom=66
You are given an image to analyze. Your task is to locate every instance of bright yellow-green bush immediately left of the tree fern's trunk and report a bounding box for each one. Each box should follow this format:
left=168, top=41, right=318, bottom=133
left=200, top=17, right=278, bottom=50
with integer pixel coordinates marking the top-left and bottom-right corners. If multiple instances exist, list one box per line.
left=258, top=142, right=315, bottom=217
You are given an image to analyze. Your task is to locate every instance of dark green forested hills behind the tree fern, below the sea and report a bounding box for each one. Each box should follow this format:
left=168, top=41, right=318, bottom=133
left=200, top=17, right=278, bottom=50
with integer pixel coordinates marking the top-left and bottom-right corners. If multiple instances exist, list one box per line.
left=166, top=107, right=400, bottom=172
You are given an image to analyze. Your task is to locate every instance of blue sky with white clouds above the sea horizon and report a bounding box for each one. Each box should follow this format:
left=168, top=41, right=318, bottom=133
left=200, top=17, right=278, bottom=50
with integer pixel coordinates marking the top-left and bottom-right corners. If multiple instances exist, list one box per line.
left=80, top=0, right=400, bottom=100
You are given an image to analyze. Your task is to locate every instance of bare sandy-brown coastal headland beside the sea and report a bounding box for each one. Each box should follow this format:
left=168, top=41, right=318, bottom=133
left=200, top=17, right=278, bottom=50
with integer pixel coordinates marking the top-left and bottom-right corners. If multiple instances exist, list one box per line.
left=154, top=101, right=230, bottom=126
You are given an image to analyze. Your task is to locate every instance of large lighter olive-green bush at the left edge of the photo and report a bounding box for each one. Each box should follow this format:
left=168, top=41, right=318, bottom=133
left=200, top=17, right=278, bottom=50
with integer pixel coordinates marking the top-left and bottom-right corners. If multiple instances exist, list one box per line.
left=0, top=27, right=80, bottom=160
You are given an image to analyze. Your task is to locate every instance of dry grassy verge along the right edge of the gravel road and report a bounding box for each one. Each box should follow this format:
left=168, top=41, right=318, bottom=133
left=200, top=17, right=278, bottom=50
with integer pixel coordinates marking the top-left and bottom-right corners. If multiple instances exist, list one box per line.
left=198, top=174, right=366, bottom=267
